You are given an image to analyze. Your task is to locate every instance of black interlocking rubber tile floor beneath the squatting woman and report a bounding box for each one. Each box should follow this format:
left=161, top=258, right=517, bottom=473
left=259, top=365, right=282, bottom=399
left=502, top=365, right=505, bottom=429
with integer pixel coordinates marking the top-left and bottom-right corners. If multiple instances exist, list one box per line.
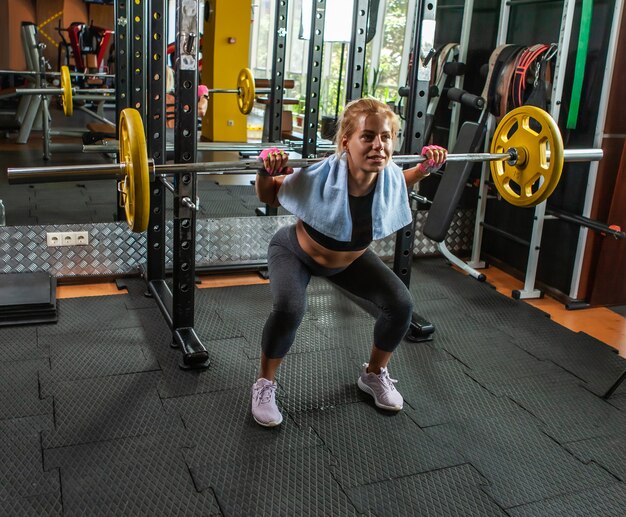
left=0, top=259, right=626, bottom=517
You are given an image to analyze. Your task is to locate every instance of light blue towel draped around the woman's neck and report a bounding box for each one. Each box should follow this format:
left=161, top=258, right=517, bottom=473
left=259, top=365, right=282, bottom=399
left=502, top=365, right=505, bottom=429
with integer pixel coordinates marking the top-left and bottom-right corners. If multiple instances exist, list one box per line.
left=278, top=153, right=412, bottom=241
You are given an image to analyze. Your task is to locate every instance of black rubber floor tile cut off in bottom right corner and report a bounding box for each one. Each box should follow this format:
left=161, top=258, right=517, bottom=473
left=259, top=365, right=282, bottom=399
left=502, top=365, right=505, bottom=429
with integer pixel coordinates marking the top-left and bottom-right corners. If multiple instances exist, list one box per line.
left=507, top=483, right=626, bottom=517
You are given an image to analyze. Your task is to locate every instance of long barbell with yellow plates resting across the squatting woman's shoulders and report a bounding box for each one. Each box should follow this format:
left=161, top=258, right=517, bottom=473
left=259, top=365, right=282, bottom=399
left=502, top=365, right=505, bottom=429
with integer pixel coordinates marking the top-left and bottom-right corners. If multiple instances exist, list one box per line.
left=7, top=106, right=603, bottom=232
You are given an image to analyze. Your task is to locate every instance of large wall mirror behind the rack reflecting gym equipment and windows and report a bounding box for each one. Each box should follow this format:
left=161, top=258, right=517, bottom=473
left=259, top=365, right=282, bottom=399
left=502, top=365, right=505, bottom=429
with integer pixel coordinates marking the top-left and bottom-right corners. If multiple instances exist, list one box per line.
left=0, top=0, right=434, bottom=225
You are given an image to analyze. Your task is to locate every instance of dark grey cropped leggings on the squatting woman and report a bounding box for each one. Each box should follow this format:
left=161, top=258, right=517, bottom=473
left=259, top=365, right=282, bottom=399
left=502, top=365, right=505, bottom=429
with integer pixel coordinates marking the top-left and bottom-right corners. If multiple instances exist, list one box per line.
left=261, top=225, right=413, bottom=359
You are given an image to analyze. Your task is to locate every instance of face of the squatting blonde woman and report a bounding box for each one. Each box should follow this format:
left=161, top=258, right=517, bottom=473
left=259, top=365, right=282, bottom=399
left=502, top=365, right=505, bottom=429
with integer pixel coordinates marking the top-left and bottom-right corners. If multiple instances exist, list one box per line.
left=343, top=113, right=393, bottom=173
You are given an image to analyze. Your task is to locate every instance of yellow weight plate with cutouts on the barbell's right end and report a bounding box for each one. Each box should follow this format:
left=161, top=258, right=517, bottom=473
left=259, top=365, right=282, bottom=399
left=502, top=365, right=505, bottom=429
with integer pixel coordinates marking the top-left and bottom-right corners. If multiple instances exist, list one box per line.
left=490, top=106, right=564, bottom=207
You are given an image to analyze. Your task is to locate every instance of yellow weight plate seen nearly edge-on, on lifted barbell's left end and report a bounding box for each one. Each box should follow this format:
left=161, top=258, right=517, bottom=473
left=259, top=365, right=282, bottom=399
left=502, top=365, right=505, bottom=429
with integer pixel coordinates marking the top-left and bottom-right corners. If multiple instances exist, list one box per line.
left=119, top=108, right=150, bottom=233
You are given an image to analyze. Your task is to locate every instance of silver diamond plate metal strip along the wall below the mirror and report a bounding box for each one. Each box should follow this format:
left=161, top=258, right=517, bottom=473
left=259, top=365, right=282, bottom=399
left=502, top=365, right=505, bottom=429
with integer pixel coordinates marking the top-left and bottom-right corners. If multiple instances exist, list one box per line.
left=0, top=210, right=474, bottom=278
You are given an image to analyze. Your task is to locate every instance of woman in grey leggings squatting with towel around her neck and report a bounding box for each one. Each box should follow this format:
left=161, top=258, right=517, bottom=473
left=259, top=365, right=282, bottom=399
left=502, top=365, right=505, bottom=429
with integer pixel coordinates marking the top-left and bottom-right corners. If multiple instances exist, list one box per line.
left=252, top=99, right=447, bottom=427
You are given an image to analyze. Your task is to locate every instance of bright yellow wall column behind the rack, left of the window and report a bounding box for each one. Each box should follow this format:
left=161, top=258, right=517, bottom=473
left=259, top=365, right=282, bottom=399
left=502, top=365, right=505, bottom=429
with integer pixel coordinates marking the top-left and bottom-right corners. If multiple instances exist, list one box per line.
left=201, top=0, right=252, bottom=142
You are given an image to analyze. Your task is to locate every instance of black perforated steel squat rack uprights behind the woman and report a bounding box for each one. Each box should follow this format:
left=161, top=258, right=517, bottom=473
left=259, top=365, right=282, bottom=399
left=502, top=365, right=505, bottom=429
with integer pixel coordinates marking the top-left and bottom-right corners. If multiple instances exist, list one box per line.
left=105, top=0, right=464, bottom=368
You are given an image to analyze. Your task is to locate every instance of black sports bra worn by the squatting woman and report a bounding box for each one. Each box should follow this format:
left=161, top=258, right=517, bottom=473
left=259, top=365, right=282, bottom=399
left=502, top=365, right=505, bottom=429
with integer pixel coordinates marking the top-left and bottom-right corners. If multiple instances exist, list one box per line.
left=302, top=189, right=376, bottom=251
